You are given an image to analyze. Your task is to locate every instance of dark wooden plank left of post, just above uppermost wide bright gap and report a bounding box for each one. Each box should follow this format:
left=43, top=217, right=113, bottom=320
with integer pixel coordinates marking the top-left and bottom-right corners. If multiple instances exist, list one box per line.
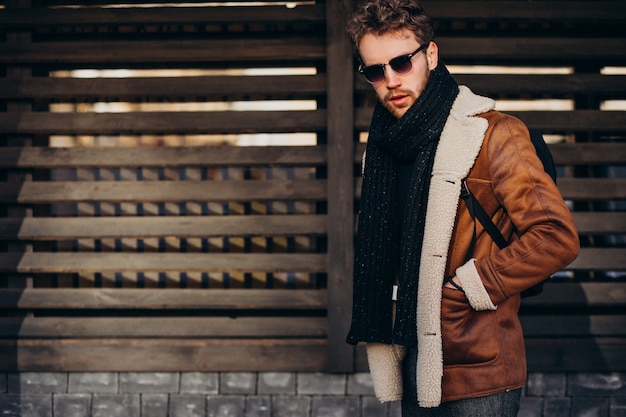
left=0, top=36, right=324, bottom=63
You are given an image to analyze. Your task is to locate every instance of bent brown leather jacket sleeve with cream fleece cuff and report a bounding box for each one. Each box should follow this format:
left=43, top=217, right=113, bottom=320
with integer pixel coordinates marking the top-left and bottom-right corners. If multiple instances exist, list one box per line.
left=457, top=116, right=580, bottom=305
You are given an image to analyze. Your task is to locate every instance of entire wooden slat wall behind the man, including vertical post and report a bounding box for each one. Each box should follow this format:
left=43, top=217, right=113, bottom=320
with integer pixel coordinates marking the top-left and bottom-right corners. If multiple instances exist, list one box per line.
left=0, top=0, right=626, bottom=372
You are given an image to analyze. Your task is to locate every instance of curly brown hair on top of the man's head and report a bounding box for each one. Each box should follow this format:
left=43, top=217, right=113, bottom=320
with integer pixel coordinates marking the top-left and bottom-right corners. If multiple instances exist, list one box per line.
left=346, top=0, right=435, bottom=48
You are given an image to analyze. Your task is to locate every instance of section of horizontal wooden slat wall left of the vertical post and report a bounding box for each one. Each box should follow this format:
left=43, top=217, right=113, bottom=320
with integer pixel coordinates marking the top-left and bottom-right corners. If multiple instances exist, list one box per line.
left=0, top=2, right=336, bottom=371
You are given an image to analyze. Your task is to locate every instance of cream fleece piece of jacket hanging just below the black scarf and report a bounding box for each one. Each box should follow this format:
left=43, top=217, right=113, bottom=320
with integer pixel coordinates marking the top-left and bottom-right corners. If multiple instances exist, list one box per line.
left=366, top=343, right=406, bottom=403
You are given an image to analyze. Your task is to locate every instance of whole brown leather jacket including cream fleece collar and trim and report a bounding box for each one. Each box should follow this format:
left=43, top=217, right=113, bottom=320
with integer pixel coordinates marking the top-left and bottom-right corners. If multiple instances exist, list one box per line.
left=367, top=86, right=579, bottom=407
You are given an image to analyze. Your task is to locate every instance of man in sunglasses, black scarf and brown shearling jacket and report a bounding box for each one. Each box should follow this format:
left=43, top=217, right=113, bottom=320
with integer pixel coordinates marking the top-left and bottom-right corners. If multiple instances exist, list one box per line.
left=347, top=0, right=579, bottom=417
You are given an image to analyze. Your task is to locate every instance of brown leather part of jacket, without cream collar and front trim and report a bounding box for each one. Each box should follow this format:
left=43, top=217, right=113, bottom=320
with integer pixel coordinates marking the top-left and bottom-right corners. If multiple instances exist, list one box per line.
left=441, top=111, right=579, bottom=401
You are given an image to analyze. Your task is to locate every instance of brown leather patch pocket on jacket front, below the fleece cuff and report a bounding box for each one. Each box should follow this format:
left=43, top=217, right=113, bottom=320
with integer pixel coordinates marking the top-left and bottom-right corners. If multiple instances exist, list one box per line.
left=441, top=287, right=500, bottom=366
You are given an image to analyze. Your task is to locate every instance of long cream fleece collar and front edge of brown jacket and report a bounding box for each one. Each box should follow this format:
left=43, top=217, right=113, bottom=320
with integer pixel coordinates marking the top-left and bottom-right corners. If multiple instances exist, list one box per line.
left=417, top=86, right=495, bottom=407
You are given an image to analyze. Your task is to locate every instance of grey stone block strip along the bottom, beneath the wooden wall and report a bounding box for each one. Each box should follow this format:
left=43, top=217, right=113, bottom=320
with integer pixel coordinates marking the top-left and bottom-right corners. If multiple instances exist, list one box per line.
left=0, top=372, right=626, bottom=417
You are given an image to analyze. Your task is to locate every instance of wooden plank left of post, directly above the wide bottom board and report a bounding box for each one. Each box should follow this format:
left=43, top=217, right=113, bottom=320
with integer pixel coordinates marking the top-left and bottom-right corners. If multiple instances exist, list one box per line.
left=0, top=316, right=328, bottom=340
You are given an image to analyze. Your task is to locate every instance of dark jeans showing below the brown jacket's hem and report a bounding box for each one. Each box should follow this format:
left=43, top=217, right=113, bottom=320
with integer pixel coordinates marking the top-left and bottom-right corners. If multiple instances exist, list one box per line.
left=402, top=348, right=522, bottom=417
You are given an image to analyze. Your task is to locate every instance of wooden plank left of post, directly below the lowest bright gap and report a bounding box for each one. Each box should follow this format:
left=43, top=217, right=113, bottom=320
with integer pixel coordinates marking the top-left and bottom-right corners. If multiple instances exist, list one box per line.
left=0, top=145, right=327, bottom=168
